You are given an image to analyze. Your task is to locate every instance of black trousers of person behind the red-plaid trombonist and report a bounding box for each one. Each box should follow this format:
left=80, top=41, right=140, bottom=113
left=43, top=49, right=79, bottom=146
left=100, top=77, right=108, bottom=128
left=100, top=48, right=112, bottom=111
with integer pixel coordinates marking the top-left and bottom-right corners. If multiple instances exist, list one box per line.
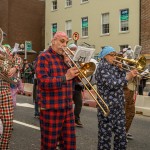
left=73, top=90, right=82, bottom=121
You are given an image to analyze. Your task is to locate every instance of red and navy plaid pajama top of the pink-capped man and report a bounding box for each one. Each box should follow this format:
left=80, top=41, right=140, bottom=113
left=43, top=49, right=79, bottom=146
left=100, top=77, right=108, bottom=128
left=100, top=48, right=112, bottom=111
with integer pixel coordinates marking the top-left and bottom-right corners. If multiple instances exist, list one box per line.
left=35, top=48, right=73, bottom=109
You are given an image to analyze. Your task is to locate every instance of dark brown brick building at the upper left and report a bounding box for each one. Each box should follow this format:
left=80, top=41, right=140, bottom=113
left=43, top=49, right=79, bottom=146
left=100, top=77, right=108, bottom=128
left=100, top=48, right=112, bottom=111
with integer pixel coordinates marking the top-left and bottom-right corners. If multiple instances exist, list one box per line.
left=0, top=0, right=45, bottom=62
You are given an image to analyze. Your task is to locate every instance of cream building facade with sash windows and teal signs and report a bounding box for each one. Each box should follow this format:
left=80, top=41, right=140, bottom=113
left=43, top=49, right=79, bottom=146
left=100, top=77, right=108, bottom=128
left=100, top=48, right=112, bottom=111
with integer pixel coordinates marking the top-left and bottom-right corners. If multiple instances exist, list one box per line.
left=45, top=0, right=140, bottom=55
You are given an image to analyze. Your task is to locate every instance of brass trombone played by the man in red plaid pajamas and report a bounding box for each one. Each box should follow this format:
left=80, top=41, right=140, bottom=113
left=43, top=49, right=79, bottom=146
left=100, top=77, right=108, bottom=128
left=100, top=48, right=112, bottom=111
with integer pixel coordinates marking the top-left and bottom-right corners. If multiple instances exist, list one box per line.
left=62, top=47, right=110, bottom=117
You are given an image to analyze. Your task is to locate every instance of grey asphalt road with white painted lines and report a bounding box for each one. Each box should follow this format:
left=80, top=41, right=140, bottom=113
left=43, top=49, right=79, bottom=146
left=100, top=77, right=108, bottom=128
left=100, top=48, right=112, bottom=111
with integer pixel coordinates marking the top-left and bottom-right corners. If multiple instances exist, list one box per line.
left=10, top=95, right=150, bottom=150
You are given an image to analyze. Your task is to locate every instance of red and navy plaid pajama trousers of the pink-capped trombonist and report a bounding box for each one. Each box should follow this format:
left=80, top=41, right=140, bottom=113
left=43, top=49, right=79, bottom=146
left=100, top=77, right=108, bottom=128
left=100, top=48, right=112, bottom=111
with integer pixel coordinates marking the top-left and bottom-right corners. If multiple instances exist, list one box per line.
left=40, top=108, right=76, bottom=150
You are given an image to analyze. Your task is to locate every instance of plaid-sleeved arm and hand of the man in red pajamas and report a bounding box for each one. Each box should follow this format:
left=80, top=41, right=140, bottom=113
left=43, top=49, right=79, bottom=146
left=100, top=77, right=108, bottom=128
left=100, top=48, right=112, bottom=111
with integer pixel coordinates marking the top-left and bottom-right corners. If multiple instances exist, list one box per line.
left=35, top=55, right=78, bottom=90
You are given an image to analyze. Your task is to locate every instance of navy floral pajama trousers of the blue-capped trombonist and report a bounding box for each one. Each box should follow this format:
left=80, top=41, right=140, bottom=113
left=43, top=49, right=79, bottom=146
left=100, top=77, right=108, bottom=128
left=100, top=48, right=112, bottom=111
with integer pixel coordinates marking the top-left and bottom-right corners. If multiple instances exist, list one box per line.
left=97, top=108, right=127, bottom=150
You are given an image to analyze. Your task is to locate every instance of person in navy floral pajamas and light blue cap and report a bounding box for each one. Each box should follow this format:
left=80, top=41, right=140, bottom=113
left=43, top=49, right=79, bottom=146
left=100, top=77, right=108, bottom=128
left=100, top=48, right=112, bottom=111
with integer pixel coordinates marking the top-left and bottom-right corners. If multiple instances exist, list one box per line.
left=95, top=46, right=137, bottom=150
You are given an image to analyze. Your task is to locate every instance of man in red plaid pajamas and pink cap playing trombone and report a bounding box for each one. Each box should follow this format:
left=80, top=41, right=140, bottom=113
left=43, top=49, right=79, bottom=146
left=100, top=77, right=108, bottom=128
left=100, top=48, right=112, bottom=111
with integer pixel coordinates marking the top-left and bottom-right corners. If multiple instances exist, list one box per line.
left=36, top=32, right=79, bottom=150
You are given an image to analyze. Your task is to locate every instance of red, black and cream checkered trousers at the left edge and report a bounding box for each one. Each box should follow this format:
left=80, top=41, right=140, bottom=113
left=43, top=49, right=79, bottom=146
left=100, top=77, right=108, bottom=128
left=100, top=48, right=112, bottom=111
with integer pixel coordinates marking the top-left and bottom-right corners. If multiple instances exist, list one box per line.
left=0, top=79, right=13, bottom=150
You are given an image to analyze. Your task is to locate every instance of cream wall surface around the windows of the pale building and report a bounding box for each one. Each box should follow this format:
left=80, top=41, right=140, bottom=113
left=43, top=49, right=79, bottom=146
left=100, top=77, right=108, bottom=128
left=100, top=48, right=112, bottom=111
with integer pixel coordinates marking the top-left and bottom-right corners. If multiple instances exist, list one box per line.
left=45, top=0, right=139, bottom=52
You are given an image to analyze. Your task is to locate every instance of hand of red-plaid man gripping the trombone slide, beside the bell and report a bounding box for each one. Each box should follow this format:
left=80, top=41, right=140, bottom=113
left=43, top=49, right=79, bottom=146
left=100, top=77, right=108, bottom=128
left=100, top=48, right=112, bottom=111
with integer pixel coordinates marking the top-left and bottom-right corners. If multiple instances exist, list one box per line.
left=65, top=67, right=79, bottom=80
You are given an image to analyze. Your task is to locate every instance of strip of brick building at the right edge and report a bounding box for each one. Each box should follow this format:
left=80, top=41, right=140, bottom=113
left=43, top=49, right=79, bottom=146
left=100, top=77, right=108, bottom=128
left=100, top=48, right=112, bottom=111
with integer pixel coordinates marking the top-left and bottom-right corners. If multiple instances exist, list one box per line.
left=140, top=0, right=150, bottom=64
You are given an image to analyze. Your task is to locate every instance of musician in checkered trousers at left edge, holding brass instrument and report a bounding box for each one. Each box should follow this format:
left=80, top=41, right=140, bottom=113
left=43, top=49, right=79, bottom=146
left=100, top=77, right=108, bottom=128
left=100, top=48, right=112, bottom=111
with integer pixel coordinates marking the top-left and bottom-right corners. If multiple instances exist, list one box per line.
left=0, top=41, right=20, bottom=150
